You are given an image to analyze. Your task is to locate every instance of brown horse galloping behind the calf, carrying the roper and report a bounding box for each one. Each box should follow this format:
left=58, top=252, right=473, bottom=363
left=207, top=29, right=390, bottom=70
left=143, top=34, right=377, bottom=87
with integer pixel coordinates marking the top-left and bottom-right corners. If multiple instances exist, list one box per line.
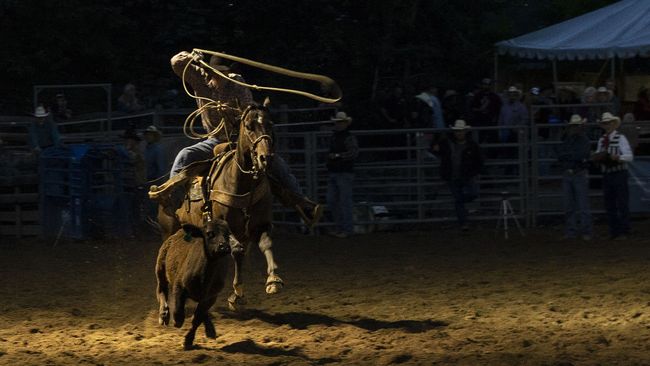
left=158, top=99, right=283, bottom=311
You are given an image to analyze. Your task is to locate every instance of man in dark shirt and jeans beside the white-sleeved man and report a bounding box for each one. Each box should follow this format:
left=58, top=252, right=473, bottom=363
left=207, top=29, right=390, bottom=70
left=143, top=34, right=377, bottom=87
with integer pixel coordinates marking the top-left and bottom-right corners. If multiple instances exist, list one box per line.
left=557, top=114, right=592, bottom=241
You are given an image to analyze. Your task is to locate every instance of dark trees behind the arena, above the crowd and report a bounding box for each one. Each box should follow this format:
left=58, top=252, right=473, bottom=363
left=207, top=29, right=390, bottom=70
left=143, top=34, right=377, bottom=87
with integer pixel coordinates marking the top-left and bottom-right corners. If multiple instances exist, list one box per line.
left=0, top=0, right=614, bottom=120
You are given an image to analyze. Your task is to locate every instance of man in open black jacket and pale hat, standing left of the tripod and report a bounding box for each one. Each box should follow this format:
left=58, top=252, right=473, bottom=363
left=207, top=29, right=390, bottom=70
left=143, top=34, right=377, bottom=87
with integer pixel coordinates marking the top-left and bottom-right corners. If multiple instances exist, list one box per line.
left=431, top=120, right=483, bottom=231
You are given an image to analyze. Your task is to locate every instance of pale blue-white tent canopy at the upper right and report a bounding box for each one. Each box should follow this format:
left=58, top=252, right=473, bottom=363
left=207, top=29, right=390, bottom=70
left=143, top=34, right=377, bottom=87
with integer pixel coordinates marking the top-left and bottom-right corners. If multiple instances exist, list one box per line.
left=496, top=0, right=650, bottom=61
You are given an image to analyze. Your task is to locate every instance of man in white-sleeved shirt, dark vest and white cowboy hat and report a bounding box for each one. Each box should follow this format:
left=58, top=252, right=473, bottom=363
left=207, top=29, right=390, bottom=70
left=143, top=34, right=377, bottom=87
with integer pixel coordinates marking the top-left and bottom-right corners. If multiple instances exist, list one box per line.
left=592, top=112, right=634, bottom=240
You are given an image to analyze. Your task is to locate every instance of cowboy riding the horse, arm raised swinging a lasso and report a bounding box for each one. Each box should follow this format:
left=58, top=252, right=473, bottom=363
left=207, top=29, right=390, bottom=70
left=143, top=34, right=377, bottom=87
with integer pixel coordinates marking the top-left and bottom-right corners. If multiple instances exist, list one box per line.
left=149, top=51, right=322, bottom=227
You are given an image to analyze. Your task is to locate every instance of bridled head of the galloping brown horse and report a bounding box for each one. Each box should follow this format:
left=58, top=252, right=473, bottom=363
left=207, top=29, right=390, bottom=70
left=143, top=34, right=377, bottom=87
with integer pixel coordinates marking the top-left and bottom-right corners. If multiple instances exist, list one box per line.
left=237, top=99, right=273, bottom=173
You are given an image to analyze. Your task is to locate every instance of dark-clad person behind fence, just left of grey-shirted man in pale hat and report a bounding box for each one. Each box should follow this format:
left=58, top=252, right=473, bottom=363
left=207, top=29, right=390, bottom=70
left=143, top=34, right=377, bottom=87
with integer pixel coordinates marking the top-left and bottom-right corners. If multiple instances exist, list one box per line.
left=469, top=78, right=503, bottom=141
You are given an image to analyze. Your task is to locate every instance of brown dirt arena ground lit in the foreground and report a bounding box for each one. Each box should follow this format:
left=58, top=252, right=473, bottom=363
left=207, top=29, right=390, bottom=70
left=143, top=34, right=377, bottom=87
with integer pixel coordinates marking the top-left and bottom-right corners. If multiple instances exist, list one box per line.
left=0, top=221, right=650, bottom=365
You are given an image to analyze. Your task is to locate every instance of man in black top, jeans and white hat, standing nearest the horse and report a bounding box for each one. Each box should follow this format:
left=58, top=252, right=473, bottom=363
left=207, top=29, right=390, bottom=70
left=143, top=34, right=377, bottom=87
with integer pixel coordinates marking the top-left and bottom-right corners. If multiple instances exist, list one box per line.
left=327, top=112, right=359, bottom=238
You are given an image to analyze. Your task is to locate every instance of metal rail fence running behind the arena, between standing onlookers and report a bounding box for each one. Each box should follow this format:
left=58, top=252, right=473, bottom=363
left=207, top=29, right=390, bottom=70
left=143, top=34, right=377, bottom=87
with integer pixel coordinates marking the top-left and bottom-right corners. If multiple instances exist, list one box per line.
left=0, top=101, right=650, bottom=236
